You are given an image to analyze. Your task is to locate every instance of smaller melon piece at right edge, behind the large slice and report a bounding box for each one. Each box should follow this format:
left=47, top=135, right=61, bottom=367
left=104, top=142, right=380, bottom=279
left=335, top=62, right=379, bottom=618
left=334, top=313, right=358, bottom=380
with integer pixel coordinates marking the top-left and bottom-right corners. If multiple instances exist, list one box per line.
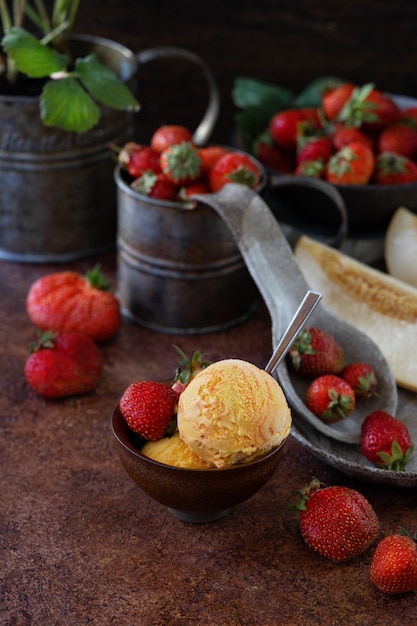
left=385, top=207, right=417, bottom=287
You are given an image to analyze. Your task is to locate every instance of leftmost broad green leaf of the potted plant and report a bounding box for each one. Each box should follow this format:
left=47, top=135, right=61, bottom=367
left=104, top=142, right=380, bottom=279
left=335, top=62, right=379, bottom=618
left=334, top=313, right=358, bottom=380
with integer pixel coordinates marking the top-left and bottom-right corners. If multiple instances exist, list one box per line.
left=2, top=27, right=68, bottom=78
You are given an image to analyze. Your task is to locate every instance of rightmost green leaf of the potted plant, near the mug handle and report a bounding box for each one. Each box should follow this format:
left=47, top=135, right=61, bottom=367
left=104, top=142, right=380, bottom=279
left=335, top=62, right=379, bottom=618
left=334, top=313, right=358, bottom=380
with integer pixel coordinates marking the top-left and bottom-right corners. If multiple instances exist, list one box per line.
left=75, top=54, right=140, bottom=111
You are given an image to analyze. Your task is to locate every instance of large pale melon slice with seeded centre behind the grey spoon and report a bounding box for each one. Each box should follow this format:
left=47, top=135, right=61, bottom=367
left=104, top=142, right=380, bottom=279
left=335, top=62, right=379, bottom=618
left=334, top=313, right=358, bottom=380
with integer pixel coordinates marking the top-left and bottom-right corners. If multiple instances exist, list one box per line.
left=294, top=236, right=417, bottom=391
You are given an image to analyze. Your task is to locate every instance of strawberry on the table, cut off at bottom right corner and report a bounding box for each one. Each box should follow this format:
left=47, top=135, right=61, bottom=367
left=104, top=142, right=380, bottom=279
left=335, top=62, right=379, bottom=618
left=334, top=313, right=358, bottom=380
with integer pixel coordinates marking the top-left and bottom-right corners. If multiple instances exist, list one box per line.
left=370, top=534, right=417, bottom=595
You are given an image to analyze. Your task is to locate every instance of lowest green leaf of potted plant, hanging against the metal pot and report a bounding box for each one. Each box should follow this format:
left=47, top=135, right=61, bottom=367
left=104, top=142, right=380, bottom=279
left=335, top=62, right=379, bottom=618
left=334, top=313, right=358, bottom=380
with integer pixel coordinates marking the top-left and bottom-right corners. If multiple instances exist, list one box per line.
left=40, top=76, right=100, bottom=133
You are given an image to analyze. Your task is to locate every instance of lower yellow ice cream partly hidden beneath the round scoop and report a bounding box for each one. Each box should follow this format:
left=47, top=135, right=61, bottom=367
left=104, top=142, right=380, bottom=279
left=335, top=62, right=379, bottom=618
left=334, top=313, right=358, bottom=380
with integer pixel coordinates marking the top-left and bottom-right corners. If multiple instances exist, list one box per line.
left=141, top=431, right=214, bottom=469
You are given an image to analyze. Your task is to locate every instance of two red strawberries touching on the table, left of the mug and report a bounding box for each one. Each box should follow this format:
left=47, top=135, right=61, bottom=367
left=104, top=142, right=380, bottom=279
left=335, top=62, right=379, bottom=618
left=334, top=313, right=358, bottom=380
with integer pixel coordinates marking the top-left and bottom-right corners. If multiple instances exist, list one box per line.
left=24, top=266, right=121, bottom=398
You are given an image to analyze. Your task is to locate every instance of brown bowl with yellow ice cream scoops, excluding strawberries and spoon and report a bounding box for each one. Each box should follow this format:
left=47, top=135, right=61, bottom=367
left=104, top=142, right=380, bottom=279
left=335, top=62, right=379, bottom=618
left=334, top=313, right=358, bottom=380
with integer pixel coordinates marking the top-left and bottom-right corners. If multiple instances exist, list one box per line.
left=112, top=358, right=291, bottom=523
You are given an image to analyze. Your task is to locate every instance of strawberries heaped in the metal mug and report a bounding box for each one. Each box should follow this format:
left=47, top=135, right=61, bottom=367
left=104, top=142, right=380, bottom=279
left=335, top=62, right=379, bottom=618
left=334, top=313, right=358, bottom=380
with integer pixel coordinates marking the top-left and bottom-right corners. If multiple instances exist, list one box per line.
left=118, top=125, right=261, bottom=202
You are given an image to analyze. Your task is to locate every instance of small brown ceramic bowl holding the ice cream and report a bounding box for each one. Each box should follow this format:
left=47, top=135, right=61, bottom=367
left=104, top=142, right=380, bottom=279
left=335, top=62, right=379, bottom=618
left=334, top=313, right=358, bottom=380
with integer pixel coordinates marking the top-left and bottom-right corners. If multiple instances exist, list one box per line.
left=112, top=407, right=285, bottom=523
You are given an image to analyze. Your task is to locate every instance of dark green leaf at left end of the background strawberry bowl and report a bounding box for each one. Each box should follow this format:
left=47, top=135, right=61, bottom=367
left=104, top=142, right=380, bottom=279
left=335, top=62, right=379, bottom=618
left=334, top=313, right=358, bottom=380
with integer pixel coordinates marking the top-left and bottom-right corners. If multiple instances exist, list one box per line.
left=232, top=77, right=294, bottom=111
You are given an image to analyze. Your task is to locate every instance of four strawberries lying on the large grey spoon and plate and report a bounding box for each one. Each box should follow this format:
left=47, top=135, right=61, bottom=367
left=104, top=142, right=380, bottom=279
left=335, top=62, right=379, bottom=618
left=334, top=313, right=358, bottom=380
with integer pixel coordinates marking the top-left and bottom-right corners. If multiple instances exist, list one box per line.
left=288, top=326, right=413, bottom=471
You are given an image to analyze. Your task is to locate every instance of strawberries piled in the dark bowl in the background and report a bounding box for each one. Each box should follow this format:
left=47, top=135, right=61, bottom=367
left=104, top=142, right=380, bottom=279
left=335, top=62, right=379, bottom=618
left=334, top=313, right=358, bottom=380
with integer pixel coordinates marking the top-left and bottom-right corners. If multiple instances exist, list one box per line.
left=255, top=82, right=417, bottom=185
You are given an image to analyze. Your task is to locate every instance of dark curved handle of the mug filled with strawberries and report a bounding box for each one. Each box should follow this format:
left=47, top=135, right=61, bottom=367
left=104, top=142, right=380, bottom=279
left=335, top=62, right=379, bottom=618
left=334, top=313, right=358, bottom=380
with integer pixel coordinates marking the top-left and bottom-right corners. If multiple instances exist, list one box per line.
left=268, top=174, right=348, bottom=248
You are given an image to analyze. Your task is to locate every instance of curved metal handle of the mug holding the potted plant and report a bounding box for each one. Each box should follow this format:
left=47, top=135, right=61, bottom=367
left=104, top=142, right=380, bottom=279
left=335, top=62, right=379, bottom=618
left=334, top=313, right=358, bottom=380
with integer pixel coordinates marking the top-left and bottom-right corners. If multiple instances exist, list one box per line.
left=137, top=46, right=220, bottom=146
